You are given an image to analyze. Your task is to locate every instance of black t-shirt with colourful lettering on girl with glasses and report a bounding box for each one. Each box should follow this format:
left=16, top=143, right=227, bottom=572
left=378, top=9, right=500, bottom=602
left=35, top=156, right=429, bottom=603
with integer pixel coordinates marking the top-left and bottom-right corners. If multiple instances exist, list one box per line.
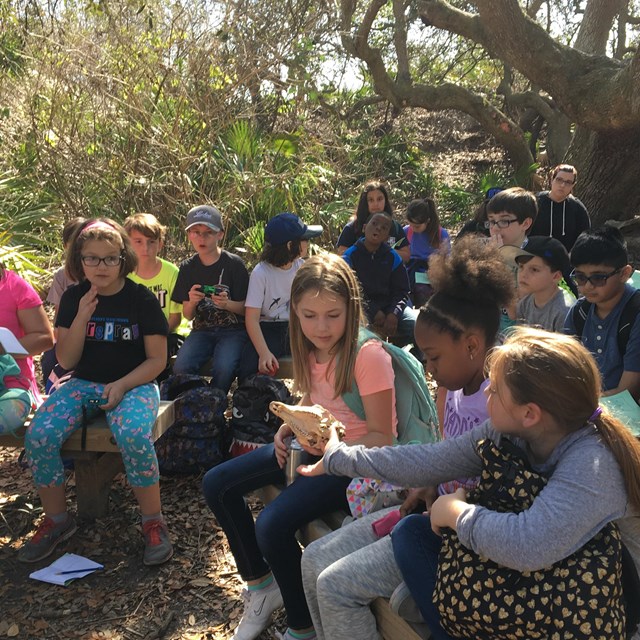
left=56, top=278, right=168, bottom=384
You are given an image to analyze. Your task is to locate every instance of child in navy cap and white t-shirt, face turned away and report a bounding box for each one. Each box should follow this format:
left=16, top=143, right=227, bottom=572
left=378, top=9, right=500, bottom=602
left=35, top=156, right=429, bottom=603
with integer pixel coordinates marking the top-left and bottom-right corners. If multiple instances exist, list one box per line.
left=238, top=213, right=322, bottom=380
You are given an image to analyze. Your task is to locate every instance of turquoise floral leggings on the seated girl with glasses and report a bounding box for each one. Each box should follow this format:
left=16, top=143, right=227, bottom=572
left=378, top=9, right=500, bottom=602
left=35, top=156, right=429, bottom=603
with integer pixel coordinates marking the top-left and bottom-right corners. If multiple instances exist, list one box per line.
left=25, top=378, right=160, bottom=487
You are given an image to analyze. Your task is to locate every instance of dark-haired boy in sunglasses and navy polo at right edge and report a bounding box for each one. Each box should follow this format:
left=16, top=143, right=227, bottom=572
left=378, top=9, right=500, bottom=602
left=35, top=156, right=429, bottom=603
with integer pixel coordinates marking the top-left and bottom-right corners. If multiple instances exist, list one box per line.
left=564, top=225, right=640, bottom=402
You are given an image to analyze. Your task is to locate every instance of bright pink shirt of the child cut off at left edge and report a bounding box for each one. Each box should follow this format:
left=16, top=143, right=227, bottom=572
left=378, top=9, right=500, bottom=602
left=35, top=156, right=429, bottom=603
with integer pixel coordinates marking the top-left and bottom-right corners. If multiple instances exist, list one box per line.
left=0, top=269, right=42, bottom=404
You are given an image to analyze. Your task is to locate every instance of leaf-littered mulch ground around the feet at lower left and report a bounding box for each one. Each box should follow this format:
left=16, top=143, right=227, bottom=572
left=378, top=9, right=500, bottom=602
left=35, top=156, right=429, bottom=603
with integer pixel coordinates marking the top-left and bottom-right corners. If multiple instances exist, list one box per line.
left=0, top=448, right=286, bottom=640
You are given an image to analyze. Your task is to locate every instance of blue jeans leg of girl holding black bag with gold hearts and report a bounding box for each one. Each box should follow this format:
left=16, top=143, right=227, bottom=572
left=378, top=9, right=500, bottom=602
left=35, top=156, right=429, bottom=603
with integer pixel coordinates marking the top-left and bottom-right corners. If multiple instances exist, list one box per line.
left=391, top=514, right=453, bottom=640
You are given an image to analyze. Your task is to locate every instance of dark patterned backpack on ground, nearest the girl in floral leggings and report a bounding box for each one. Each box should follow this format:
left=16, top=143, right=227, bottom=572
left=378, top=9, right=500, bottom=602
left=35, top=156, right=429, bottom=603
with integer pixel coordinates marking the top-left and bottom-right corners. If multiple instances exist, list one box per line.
left=155, top=374, right=227, bottom=475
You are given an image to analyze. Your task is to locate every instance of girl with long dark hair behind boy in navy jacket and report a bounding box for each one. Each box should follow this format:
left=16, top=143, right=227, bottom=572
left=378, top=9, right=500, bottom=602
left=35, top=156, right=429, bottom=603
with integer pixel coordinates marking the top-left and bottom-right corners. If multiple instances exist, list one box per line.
left=336, top=180, right=411, bottom=262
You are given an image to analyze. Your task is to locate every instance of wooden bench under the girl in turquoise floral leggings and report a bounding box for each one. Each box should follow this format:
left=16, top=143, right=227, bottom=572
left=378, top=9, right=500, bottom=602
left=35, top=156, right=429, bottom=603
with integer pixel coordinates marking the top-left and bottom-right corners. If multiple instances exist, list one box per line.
left=0, top=402, right=174, bottom=519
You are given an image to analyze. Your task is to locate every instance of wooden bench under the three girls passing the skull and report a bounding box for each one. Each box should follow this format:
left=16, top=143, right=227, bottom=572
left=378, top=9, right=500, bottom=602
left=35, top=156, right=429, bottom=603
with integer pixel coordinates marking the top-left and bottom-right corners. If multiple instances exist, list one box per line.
left=254, top=485, right=431, bottom=640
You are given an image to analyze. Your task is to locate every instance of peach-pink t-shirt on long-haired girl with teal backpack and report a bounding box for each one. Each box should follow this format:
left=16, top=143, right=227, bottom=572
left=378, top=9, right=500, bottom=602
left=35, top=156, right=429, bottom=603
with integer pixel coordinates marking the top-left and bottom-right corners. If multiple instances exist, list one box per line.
left=309, top=340, right=398, bottom=442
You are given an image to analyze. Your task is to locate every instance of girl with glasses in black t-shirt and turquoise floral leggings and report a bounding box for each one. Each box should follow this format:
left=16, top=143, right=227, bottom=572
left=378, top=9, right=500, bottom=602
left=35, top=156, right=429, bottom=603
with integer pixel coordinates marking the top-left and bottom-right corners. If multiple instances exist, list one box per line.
left=18, top=218, right=173, bottom=565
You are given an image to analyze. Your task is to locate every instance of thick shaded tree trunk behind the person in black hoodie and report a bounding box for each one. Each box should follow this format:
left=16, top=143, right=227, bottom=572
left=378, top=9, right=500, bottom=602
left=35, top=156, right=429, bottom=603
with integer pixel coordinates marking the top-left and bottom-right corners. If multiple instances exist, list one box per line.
left=567, top=128, right=640, bottom=226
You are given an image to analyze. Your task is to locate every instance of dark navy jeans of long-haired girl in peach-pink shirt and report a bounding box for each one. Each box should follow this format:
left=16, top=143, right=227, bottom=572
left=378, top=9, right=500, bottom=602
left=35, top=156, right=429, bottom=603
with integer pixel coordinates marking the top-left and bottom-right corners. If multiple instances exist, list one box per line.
left=202, top=444, right=351, bottom=629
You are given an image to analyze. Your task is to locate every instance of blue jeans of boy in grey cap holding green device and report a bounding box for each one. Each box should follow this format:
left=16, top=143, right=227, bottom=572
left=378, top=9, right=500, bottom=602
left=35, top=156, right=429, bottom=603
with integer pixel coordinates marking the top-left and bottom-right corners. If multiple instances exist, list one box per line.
left=173, top=326, right=249, bottom=393
